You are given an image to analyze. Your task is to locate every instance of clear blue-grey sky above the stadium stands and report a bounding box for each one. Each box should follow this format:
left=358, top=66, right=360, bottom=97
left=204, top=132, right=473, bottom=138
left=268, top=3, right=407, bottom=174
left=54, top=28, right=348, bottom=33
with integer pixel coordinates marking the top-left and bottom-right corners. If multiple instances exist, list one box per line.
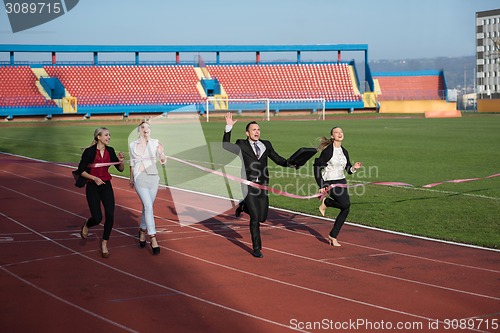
left=0, top=0, right=500, bottom=60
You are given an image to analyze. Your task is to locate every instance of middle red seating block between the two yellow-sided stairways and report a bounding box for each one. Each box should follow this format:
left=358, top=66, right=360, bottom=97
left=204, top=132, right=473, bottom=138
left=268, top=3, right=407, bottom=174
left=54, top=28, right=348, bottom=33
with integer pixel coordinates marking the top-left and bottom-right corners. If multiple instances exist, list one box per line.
left=44, top=66, right=201, bottom=106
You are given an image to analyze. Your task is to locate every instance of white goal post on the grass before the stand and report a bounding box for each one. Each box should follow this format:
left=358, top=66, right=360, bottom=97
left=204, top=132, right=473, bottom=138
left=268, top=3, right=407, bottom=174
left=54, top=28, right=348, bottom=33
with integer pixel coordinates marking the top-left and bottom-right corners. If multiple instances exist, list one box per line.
left=205, top=97, right=326, bottom=122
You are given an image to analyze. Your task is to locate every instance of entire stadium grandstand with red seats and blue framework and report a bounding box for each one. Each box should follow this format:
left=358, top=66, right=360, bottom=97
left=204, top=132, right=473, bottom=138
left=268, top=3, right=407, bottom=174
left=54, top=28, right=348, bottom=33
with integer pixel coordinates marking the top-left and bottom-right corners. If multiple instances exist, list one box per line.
left=0, top=44, right=458, bottom=119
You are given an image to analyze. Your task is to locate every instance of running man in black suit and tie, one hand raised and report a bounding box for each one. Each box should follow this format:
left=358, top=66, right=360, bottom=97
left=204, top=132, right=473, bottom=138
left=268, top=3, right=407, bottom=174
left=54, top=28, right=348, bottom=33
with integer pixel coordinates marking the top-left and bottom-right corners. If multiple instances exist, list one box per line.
left=222, top=112, right=290, bottom=258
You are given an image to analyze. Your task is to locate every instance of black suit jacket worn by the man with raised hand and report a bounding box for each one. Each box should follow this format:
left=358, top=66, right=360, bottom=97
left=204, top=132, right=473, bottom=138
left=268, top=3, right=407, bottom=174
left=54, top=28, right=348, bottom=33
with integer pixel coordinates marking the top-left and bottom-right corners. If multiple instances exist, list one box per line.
left=222, top=132, right=288, bottom=185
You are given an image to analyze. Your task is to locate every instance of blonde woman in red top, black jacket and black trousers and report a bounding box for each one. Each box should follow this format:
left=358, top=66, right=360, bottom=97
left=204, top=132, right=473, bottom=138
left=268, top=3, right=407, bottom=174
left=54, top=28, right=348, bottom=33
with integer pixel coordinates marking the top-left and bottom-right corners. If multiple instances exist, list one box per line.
left=78, top=127, right=125, bottom=258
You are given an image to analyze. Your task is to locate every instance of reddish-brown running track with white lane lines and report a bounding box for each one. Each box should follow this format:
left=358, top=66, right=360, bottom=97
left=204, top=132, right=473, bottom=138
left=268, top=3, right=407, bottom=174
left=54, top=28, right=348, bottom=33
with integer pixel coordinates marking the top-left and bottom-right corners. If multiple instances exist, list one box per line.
left=0, top=155, right=500, bottom=333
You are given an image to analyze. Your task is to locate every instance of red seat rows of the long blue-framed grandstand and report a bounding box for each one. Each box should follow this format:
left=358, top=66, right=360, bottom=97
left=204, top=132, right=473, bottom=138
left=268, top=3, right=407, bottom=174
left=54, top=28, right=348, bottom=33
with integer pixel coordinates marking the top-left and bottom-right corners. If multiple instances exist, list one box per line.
left=0, top=63, right=361, bottom=108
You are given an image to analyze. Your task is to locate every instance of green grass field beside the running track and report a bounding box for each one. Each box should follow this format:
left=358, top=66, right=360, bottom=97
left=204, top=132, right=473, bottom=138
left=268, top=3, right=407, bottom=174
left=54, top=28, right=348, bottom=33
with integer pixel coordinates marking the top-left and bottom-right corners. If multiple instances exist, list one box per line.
left=0, top=114, right=500, bottom=248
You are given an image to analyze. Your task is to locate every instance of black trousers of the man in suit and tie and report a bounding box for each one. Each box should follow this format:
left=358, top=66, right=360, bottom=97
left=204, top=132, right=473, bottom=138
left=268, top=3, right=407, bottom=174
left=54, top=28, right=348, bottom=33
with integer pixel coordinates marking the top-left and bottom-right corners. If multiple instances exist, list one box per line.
left=243, top=186, right=269, bottom=250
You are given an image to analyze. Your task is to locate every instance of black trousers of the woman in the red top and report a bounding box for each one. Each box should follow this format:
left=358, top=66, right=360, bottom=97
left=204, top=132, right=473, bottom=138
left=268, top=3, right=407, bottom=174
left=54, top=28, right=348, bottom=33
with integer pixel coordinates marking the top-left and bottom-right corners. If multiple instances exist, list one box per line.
left=85, top=180, right=115, bottom=240
